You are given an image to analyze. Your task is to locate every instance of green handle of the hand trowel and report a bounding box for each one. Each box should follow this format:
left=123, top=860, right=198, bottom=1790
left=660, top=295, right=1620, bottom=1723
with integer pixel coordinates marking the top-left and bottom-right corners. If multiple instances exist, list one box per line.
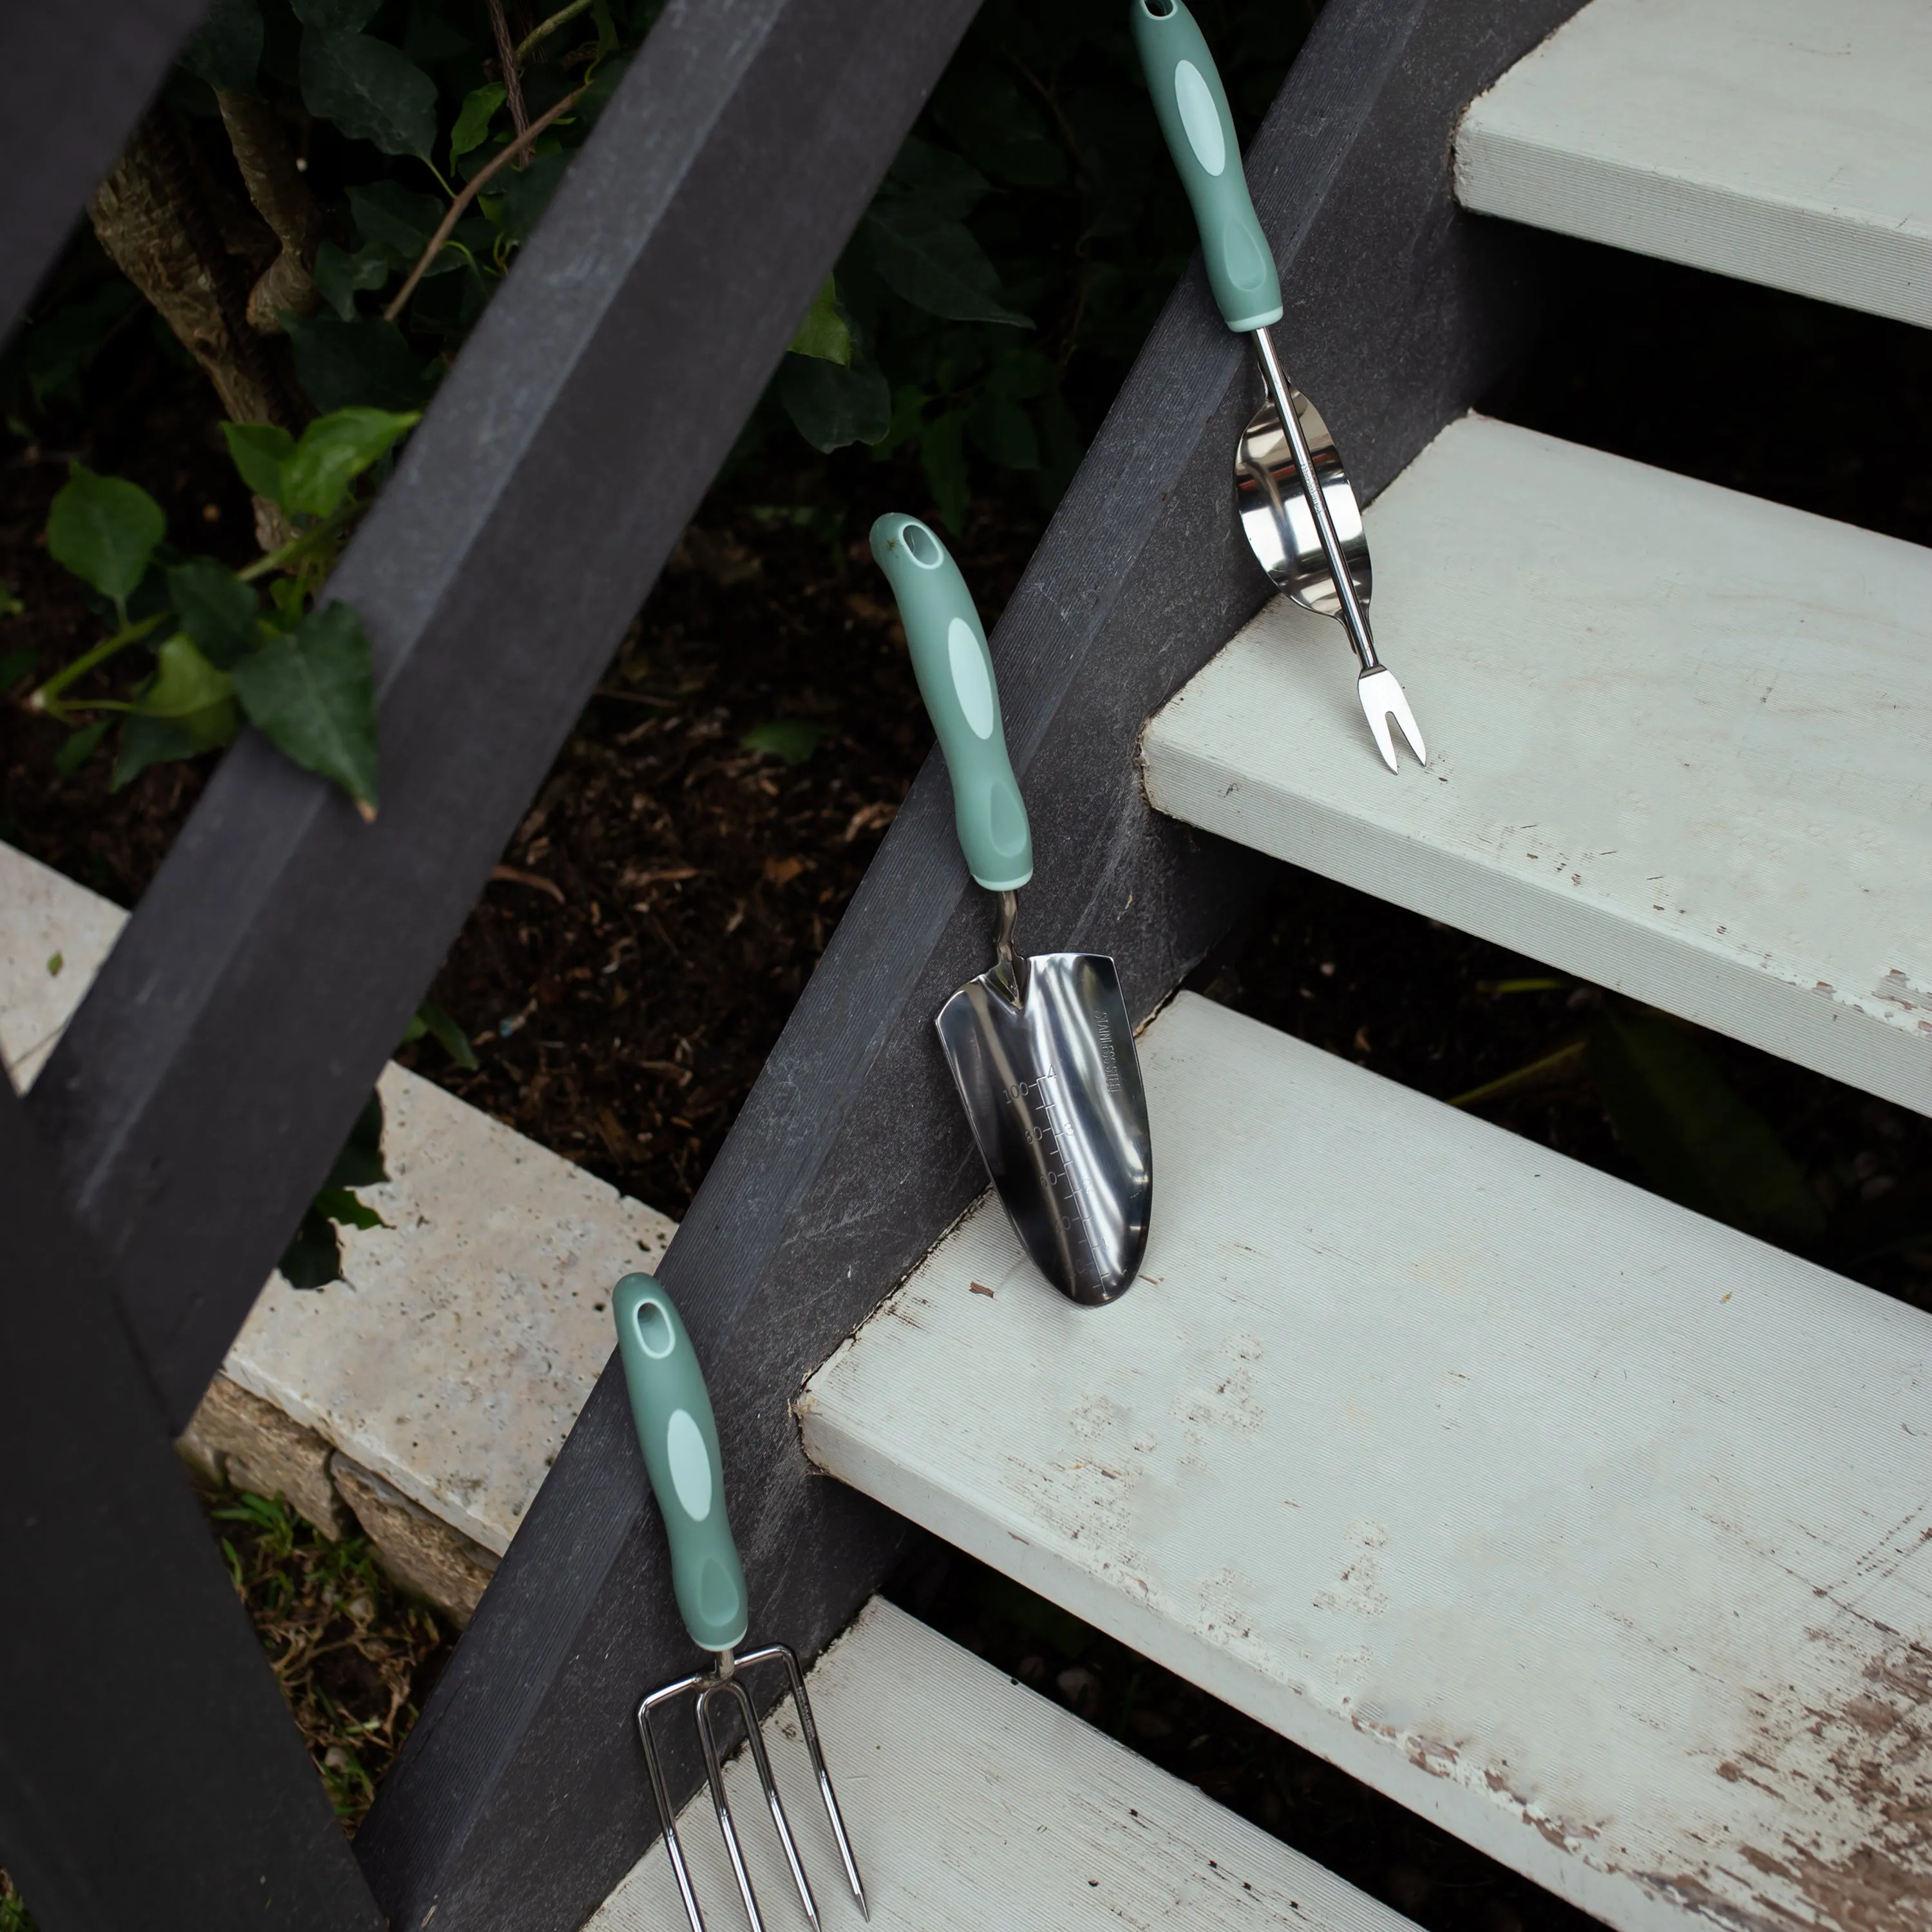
left=871, top=512, right=1034, bottom=893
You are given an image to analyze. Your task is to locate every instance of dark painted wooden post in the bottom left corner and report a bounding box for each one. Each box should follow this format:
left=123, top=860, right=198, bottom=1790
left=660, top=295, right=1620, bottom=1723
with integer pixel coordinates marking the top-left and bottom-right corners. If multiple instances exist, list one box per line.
left=0, top=1076, right=383, bottom=1932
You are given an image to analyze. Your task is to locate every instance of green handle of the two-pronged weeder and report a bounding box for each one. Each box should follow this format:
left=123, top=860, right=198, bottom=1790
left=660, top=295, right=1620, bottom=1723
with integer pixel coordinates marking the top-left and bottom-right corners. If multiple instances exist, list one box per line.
left=1128, top=0, right=1281, bottom=330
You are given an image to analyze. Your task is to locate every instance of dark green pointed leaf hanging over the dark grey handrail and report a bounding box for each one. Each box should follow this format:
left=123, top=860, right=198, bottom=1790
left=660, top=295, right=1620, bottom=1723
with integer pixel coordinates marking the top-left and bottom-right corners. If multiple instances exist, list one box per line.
left=234, top=603, right=375, bottom=819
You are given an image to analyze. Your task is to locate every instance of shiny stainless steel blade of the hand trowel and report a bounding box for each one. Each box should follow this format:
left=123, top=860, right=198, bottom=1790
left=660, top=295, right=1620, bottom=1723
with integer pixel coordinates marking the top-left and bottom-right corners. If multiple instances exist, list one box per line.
left=937, top=952, right=1153, bottom=1306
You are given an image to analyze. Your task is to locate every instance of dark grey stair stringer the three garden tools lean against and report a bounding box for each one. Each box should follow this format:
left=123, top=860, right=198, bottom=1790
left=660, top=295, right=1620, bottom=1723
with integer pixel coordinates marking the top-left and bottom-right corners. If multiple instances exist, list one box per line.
left=357, top=0, right=1578, bottom=1932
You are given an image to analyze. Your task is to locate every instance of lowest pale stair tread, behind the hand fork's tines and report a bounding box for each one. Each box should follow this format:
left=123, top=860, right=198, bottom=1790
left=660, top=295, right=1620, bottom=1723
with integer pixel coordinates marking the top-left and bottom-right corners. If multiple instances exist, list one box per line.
left=585, top=1598, right=1414, bottom=1932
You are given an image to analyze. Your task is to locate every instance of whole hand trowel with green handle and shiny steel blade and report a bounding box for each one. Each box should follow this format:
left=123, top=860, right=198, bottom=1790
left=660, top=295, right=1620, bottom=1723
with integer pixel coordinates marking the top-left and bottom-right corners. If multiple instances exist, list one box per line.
left=871, top=516, right=1153, bottom=1306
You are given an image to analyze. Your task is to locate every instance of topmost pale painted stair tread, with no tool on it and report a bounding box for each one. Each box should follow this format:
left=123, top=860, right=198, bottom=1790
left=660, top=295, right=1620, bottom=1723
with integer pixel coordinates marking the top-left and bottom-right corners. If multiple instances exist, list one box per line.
left=1455, top=0, right=1932, bottom=328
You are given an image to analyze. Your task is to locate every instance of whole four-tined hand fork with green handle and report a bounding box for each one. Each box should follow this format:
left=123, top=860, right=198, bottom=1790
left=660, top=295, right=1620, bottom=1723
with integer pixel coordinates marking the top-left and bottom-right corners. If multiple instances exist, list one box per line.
left=611, top=1275, right=871, bottom=1932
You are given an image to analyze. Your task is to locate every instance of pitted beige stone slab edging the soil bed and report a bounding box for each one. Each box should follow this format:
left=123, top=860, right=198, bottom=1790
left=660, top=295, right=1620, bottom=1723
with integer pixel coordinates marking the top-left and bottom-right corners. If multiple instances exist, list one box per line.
left=0, top=844, right=676, bottom=1555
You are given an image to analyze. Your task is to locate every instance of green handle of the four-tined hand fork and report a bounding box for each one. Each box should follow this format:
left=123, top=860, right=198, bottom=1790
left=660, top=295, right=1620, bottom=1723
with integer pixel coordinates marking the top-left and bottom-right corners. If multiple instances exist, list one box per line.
left=611, top=1275, right=748, bottom=1650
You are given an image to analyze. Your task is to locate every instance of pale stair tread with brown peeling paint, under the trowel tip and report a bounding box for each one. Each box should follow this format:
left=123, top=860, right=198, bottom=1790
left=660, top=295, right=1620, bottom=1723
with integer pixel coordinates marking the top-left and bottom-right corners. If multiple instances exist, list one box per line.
left=800, top=997, right=1932, bottom=1932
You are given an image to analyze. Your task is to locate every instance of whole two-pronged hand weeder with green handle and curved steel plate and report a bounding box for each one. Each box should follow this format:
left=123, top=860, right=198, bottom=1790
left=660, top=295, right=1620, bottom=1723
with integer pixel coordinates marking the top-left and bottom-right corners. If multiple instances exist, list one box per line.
left=1130, top=0, right=1430, bottom=771
